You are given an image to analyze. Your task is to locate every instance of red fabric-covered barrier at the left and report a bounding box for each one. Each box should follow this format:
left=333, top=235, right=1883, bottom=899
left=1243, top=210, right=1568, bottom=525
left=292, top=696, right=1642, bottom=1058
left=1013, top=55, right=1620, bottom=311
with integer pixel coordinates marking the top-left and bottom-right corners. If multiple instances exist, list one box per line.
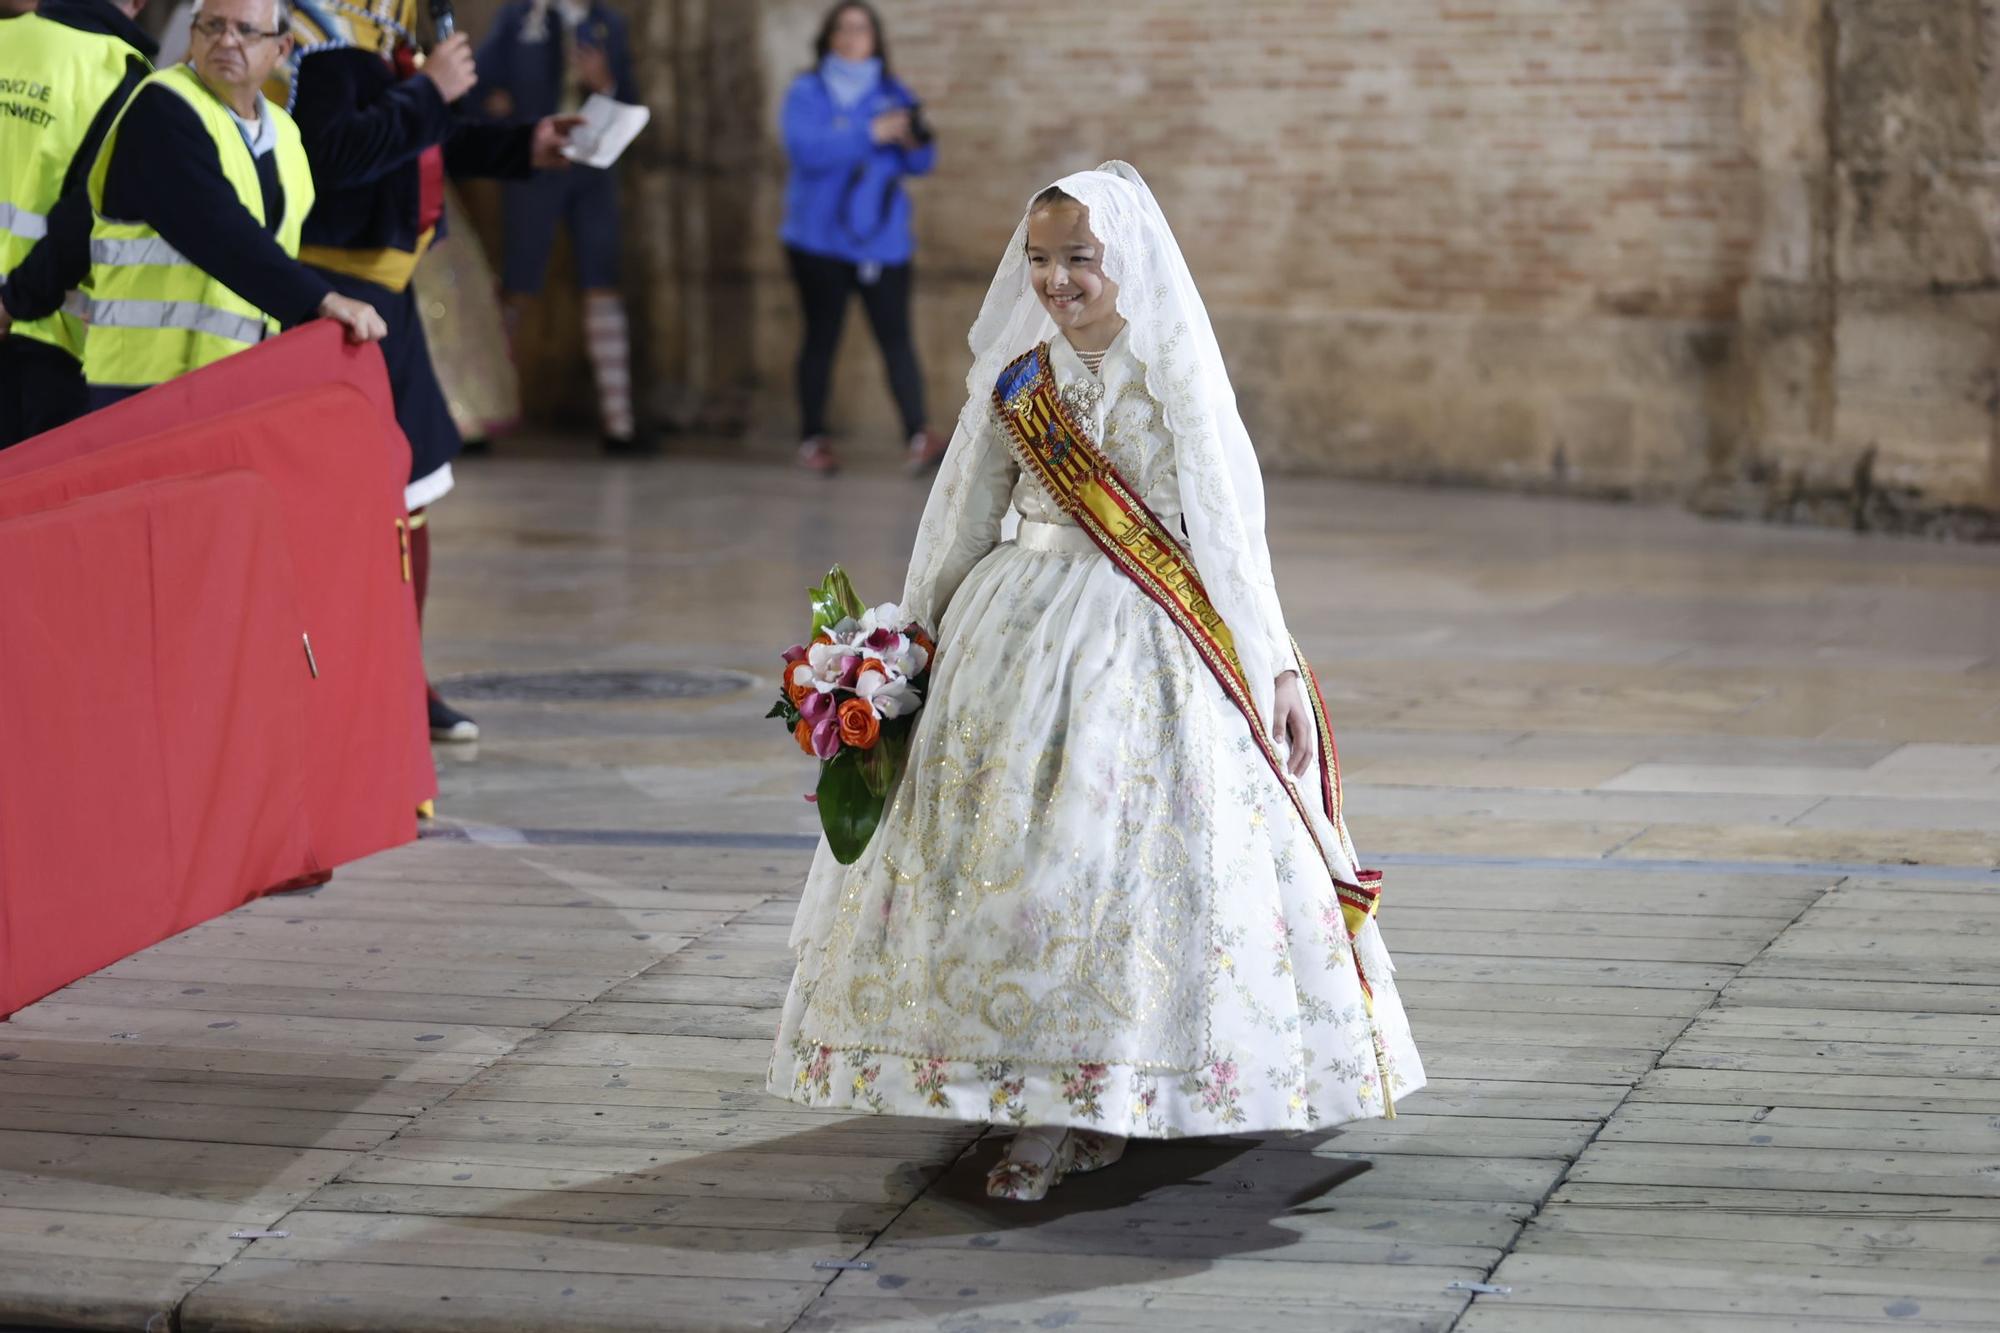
left=0, top=328, right=436, bottom=1015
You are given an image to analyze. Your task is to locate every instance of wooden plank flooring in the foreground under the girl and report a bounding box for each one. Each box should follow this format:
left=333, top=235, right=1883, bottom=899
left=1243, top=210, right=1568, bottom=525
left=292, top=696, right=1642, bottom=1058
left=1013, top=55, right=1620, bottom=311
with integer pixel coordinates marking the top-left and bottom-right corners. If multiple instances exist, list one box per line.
left=11, top=843, right=1968, bottom=1331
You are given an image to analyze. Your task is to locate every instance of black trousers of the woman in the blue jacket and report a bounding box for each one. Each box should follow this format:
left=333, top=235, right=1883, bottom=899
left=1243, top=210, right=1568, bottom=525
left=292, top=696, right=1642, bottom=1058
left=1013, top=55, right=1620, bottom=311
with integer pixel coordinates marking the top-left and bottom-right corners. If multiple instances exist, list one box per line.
left=784, top=246, right=924, bottom=438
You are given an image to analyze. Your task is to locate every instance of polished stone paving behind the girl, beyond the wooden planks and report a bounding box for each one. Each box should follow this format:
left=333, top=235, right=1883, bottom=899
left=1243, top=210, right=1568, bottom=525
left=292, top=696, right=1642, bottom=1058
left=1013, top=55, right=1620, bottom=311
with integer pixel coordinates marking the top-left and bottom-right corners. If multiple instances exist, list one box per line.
left=418, top=462, right=2000, bottom=865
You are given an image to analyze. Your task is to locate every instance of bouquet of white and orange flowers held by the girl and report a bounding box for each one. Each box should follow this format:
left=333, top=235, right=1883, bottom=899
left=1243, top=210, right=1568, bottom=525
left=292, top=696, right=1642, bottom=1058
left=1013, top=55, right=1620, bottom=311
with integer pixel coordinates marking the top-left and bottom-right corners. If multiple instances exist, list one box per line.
left=764, top=564, right=936, bottom=865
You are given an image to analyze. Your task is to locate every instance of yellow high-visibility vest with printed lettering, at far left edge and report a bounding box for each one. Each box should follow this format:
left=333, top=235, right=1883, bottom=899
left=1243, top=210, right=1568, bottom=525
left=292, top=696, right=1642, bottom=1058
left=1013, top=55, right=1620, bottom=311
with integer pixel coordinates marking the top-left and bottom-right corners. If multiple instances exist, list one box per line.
left=0, top=14, right=144, bottom=360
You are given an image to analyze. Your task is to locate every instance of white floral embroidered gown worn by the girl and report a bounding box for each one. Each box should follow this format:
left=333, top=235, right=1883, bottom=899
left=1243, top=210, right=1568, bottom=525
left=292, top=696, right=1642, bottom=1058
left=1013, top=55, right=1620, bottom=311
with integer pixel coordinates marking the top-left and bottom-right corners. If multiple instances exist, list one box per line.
left=770, top=334, right=1424, bottom=1137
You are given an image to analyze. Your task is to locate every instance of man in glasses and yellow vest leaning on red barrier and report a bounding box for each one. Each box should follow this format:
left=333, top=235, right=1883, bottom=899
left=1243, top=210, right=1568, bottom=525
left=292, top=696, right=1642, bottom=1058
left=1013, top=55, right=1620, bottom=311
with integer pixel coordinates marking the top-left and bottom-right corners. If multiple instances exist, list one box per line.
left=84, top=0, right=384, bottom=408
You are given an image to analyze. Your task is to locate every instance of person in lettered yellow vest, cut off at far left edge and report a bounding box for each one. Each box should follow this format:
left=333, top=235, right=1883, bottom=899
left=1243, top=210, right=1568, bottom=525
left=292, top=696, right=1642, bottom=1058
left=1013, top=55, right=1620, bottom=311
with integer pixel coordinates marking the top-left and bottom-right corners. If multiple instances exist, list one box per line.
left=0, top=0, right=156, bottom=448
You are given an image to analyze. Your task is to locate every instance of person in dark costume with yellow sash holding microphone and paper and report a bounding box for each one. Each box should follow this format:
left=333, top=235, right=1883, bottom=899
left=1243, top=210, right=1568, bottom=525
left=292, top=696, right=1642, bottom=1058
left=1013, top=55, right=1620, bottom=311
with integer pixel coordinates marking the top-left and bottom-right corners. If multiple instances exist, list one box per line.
left=292, top=0, right=580, bottom=741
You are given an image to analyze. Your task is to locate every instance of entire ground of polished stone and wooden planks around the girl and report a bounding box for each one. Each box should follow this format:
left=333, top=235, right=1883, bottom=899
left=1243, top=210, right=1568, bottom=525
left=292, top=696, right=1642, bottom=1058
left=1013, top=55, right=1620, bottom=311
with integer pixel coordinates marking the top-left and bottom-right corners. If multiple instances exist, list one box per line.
left=0, top=456, right=2000, bottom=1333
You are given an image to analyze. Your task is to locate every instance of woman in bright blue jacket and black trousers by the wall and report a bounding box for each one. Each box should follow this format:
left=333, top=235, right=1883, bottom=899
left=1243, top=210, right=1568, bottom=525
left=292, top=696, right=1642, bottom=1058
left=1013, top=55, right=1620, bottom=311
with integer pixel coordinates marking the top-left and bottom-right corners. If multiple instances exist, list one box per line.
left=780, top=0, right=944, bottom=472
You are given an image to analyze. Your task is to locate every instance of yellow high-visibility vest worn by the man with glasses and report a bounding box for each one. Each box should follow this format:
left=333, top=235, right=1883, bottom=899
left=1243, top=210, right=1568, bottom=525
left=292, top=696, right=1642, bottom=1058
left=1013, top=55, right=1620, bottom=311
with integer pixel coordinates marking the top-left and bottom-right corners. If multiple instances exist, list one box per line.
left=84, top=64, right=312, bottom=384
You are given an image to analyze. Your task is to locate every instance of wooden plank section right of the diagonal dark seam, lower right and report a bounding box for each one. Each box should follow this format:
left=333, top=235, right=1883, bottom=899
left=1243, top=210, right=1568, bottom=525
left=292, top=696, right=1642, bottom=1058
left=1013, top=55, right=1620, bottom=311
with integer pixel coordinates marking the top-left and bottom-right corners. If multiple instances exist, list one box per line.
left=1462, top=879, right=2000, bottom=1329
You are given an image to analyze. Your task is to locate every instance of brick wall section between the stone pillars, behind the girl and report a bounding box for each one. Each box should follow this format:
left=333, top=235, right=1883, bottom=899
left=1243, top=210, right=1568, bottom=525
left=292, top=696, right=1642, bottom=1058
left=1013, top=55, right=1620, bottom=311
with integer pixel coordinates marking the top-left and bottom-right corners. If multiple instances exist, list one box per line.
left=740, top=0, right=1756, bottom=490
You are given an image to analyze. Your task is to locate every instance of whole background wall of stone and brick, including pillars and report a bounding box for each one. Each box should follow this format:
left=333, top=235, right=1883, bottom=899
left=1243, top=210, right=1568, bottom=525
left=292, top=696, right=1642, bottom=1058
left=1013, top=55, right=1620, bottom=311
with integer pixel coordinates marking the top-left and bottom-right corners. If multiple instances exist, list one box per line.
left=462, top=0, right=2000, bottom=512
